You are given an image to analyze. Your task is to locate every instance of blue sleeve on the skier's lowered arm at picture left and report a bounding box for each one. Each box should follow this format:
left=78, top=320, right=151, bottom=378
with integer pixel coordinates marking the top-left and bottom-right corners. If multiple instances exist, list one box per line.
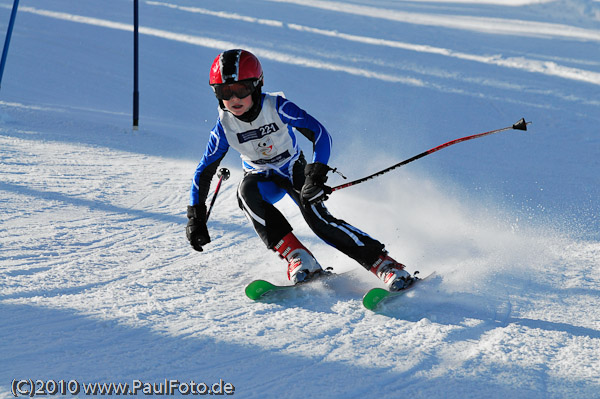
left=190, top=121, right=229, bottom=206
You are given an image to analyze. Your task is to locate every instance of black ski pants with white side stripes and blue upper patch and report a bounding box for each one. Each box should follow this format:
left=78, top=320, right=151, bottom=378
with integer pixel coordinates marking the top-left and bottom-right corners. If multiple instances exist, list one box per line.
left=237, top=169, right=384, bottom=269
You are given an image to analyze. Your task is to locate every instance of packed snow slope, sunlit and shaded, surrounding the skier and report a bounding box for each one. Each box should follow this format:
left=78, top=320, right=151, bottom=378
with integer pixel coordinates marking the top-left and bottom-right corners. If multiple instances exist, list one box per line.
left=0, top=0, right=600, bottom=399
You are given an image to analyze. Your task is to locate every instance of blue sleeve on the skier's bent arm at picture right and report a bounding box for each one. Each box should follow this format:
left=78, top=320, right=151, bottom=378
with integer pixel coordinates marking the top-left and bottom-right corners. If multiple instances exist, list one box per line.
left=277, top=96, right=332, bottom=164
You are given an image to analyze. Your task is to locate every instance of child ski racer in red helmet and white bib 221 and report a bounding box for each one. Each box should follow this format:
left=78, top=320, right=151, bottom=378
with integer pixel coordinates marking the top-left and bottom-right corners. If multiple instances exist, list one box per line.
left=186, top=49, right=414, bottom=291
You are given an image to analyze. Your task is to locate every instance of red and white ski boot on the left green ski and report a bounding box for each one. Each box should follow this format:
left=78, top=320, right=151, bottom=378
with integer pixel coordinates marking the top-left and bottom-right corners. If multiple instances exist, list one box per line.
left=273, top=232, right=323, bottom=284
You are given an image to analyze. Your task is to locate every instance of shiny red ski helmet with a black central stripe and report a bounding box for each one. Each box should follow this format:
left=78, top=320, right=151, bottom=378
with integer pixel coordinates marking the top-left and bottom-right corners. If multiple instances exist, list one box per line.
left=209, top=49, right=263, bottom=86
